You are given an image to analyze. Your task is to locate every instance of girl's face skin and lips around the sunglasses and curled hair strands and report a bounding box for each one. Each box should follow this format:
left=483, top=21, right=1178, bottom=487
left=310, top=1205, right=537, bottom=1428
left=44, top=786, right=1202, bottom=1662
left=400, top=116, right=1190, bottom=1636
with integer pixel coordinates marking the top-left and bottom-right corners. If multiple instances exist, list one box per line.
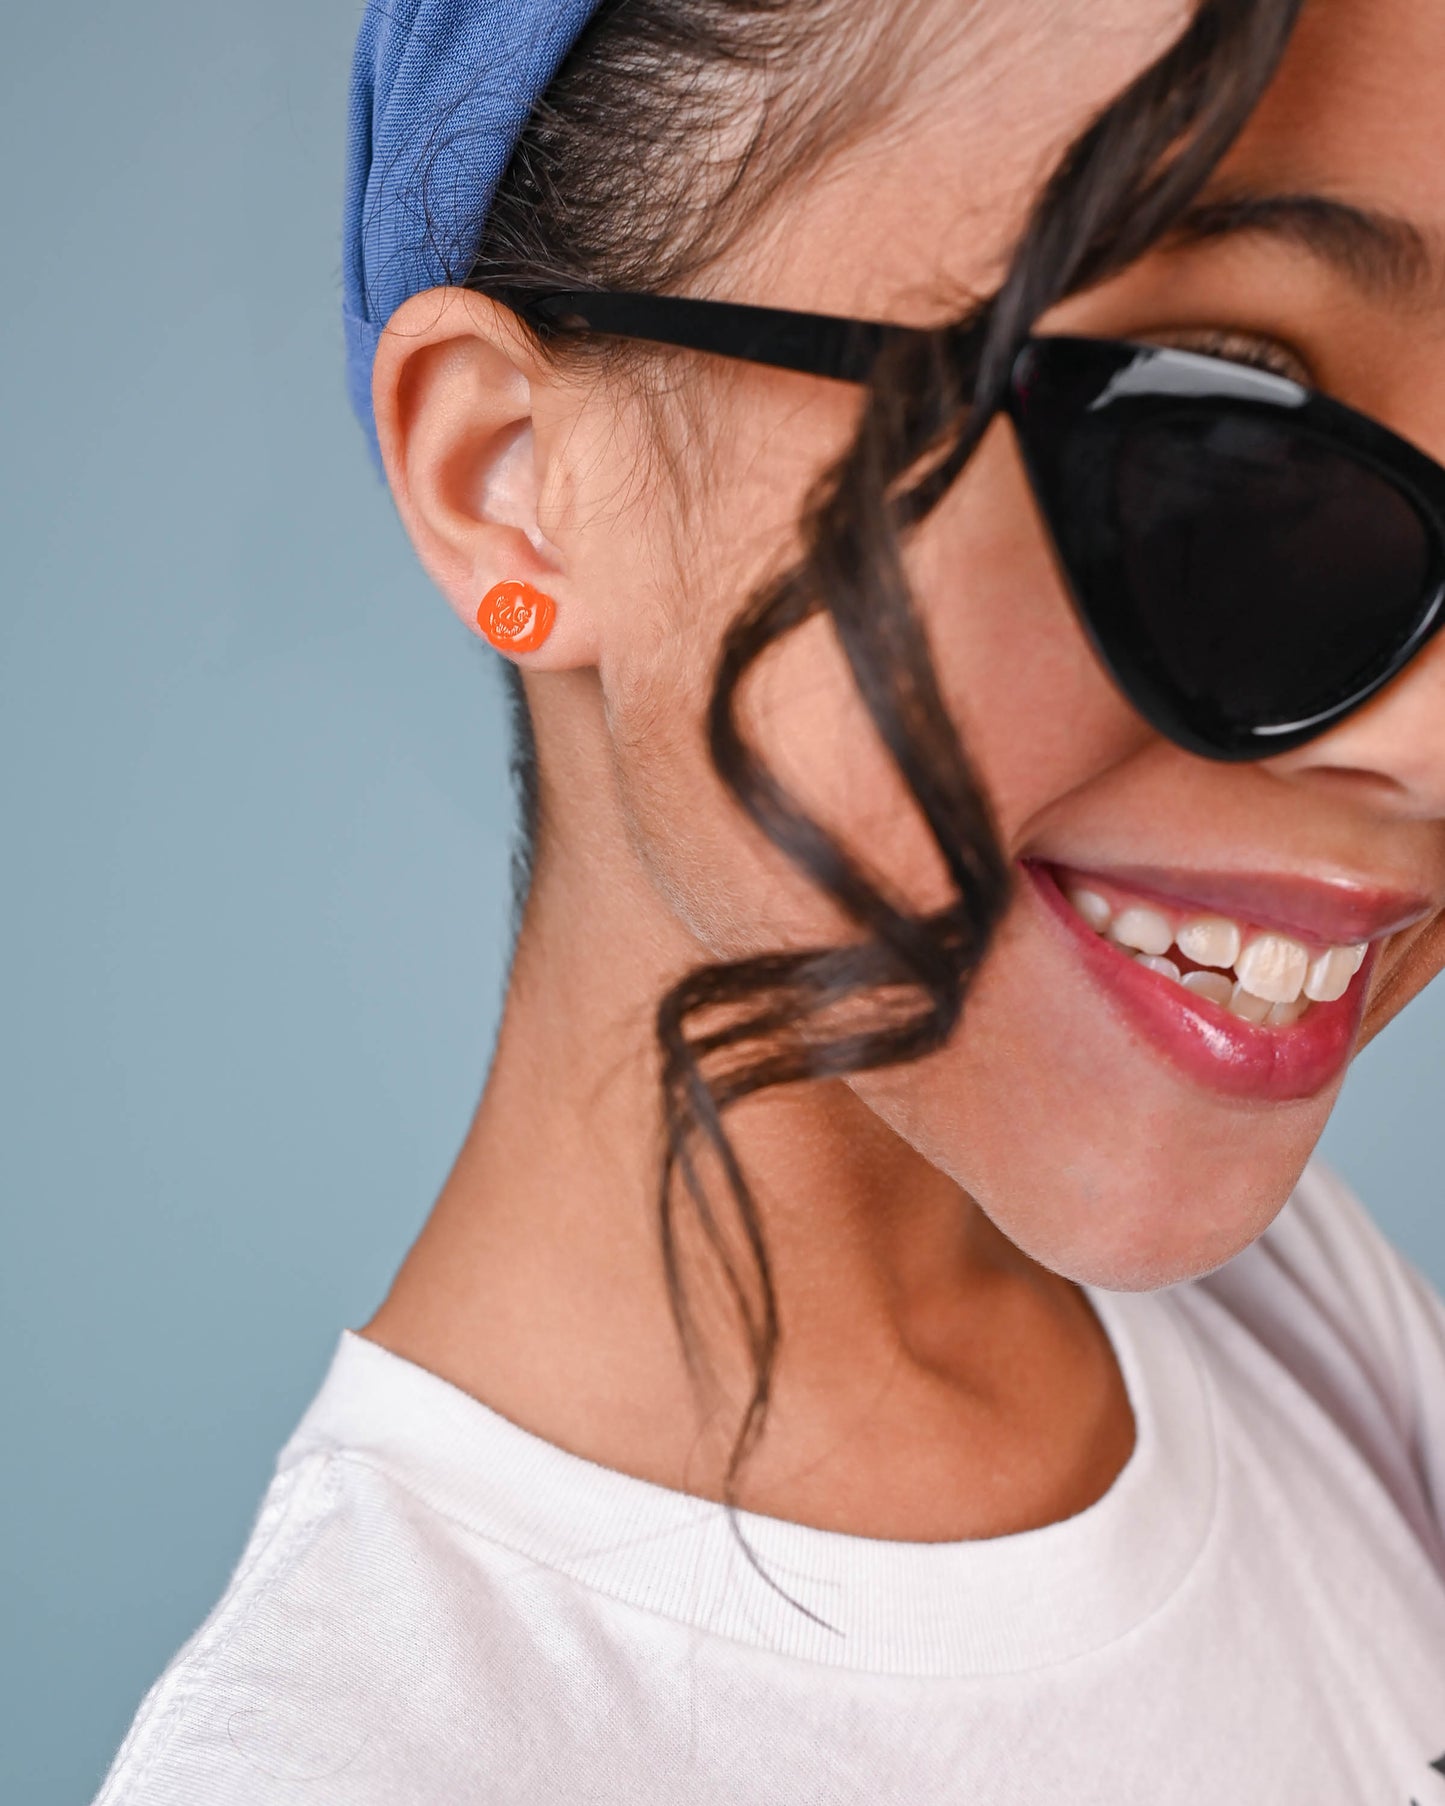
left=437, top=0, right=1445, bottom=1288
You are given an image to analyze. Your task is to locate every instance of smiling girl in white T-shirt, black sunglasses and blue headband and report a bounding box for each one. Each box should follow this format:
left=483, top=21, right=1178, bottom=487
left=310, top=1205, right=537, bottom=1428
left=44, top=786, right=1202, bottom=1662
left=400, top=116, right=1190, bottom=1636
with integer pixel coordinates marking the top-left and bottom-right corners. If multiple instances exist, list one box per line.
left=101, top=0, right=1445, bottom=1806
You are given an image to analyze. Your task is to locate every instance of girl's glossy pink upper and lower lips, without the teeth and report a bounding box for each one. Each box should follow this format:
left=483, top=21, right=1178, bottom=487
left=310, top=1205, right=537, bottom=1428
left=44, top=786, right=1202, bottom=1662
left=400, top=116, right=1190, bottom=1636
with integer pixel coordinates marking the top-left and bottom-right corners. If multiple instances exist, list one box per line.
left=1022, top=860, right=1387, bottom=1102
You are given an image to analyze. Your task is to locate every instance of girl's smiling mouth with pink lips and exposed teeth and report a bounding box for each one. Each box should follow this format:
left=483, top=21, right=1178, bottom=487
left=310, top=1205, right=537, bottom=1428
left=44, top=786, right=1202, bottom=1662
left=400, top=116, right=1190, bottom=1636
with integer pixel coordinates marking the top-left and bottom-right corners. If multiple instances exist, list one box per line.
left=1021, top=860, right=1420, bottom=1102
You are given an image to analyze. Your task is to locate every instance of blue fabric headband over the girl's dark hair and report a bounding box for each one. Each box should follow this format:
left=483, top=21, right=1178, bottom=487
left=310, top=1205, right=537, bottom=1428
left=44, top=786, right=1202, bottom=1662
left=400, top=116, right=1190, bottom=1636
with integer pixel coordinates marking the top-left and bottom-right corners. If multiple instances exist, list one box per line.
left=343, top=0, right=600, bottom=462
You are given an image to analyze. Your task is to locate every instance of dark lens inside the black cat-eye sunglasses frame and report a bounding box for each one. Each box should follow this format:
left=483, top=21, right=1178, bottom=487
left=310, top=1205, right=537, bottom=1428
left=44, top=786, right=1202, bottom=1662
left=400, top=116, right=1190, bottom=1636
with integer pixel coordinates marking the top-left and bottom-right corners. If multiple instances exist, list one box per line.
left=1111, top=406, right=1434, bottom=753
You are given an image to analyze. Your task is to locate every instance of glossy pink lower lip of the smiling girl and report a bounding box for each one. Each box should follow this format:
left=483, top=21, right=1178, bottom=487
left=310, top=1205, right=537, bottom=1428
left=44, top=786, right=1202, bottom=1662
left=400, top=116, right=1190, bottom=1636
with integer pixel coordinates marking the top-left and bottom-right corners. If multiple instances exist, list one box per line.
left=1022, top=860, right=1378, bottom=1103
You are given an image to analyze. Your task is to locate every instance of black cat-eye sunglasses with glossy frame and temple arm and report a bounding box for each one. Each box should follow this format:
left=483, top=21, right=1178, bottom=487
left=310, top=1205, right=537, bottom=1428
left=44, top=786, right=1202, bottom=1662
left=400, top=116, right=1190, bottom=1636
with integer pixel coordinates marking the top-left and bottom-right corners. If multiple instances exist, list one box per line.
left=520, top=293, right=1445, bottom=760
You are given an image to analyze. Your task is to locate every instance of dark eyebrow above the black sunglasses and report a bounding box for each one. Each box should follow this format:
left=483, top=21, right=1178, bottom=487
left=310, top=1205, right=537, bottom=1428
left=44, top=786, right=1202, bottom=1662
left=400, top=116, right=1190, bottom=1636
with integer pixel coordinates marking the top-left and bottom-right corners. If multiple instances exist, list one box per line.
left=1165, top=191, right=1445, bottom=300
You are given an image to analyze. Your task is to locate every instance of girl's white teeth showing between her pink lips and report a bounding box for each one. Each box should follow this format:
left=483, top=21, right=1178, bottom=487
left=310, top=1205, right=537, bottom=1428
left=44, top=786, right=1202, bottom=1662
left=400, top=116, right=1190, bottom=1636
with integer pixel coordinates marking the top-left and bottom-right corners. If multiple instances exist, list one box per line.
left=1069, top=889, right=1366, bottom=1022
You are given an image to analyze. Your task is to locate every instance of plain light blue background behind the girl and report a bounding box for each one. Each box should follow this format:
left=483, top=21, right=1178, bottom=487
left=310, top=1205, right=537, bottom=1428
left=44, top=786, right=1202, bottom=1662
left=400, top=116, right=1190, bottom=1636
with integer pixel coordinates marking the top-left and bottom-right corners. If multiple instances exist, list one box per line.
left=0, top=0, right=1445, bottom=1806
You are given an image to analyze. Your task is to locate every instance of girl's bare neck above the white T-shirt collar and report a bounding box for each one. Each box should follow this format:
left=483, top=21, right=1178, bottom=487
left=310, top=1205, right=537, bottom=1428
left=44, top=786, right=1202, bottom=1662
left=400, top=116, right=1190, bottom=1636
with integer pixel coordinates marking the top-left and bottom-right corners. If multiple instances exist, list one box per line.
left=367, top=798, right=1133, bottom=1541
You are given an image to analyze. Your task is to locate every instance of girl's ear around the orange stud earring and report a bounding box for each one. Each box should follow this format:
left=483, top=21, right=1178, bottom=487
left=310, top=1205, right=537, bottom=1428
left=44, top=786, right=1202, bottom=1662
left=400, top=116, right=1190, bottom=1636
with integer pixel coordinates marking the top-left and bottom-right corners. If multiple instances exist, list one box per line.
left=372, top=289, right=596, bottom=670
